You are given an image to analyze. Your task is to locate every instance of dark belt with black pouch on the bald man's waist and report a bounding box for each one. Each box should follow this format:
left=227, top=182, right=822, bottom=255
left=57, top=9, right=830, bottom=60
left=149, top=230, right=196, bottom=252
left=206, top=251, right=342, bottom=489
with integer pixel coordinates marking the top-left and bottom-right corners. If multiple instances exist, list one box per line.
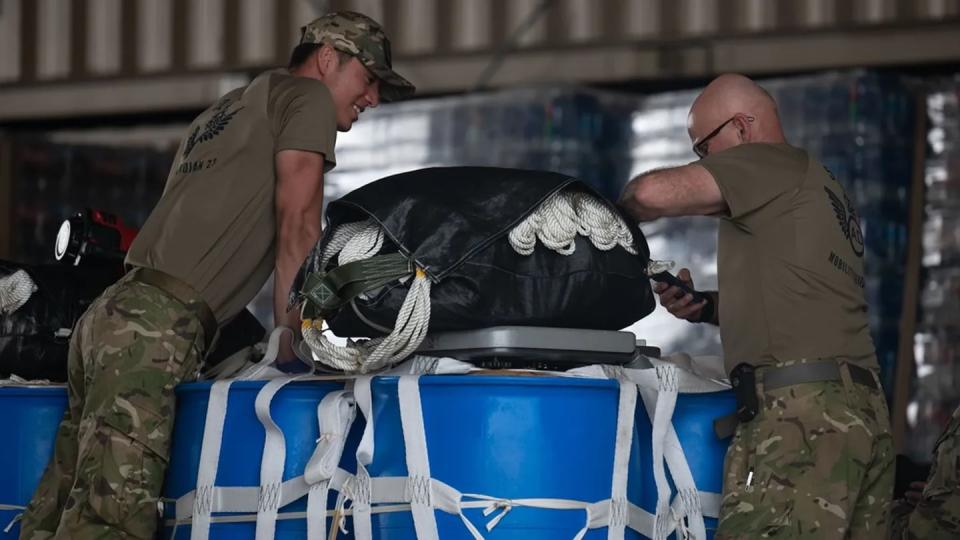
left=713, top=360, right=880, bottom=439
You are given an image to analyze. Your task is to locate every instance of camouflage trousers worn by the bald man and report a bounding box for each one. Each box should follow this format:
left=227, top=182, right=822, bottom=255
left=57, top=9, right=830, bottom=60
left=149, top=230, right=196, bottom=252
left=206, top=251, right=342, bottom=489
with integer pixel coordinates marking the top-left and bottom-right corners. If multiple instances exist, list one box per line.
left=716, top=360, right=894, bottom=540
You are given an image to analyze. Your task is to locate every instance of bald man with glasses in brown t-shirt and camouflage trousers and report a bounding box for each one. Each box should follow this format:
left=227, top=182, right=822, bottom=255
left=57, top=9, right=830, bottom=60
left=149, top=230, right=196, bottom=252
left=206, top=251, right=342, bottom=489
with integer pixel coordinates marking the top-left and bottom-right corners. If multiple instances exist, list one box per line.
left=620, top=74, right=894, bottom=539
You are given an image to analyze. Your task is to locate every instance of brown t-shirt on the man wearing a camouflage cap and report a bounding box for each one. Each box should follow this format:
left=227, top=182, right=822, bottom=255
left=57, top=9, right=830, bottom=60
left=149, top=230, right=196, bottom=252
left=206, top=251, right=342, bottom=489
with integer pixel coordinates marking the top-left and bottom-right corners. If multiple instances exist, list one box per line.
left=127, top=70, right=337, bottom=324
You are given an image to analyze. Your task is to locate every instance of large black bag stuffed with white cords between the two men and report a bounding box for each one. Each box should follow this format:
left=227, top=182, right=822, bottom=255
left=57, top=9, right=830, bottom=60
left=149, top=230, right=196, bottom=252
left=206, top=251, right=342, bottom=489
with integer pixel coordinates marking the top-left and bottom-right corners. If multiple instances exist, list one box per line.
left=291, top=167, right=655, bottom=337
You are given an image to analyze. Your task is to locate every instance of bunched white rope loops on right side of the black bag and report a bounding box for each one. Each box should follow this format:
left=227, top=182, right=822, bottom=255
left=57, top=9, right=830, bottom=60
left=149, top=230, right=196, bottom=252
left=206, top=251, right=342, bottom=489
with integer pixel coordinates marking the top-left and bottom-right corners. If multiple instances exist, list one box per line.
left=508, top=191, right=637, bottom=255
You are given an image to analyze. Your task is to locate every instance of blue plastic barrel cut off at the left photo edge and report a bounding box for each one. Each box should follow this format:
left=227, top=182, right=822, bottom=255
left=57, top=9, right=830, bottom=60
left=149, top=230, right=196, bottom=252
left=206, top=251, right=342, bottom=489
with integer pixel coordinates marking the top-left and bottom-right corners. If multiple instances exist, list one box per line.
left=0, top=386, right=67, bottom=539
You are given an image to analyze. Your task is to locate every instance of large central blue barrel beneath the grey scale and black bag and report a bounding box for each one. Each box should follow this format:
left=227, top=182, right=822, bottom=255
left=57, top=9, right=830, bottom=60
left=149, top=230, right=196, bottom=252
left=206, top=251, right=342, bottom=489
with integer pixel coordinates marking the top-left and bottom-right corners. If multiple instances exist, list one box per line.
left=360, top=376, right=643, bottom=540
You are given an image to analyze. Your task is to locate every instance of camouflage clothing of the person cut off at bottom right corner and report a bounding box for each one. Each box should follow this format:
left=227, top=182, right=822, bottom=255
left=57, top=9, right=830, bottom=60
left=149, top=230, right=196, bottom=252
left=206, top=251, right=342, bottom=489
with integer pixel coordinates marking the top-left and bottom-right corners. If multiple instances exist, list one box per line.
left=890, top=408, right=960, bottom=540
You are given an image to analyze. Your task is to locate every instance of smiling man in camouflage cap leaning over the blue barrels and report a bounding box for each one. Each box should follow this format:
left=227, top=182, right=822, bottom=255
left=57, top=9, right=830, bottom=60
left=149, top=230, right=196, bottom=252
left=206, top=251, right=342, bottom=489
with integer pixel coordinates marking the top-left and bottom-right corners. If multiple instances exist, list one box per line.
left=21, top=12, right=414, bottom=540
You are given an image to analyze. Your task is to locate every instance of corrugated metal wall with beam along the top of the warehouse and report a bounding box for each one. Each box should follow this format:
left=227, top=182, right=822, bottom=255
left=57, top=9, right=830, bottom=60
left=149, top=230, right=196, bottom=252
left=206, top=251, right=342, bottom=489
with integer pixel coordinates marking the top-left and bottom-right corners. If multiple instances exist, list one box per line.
left=0, top=0, right=960, bottom=118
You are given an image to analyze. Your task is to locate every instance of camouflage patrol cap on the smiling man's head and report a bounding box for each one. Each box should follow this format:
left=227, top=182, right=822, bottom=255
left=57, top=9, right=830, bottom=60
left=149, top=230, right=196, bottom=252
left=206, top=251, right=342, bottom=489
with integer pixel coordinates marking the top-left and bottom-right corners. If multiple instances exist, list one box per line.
left=300, top=11, right=416, bottom=101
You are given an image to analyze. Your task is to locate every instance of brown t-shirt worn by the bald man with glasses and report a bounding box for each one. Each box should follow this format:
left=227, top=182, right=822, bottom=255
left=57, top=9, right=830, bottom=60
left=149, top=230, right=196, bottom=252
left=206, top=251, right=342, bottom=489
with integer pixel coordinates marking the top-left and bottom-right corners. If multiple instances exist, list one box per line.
left=697, top=144, right=877, bottom=371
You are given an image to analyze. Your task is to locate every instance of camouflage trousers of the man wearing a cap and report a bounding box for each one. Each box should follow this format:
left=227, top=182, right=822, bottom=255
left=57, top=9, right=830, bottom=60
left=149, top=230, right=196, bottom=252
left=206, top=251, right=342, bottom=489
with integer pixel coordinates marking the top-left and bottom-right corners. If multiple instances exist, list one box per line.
left=20, top=275, right=210, bottom=540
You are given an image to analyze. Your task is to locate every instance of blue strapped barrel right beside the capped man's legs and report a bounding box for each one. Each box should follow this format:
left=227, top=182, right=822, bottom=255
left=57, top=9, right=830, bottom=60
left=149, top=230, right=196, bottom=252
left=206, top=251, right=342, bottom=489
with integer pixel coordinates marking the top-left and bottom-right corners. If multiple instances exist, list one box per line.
left=163, top=381, right=361, bottom=540
